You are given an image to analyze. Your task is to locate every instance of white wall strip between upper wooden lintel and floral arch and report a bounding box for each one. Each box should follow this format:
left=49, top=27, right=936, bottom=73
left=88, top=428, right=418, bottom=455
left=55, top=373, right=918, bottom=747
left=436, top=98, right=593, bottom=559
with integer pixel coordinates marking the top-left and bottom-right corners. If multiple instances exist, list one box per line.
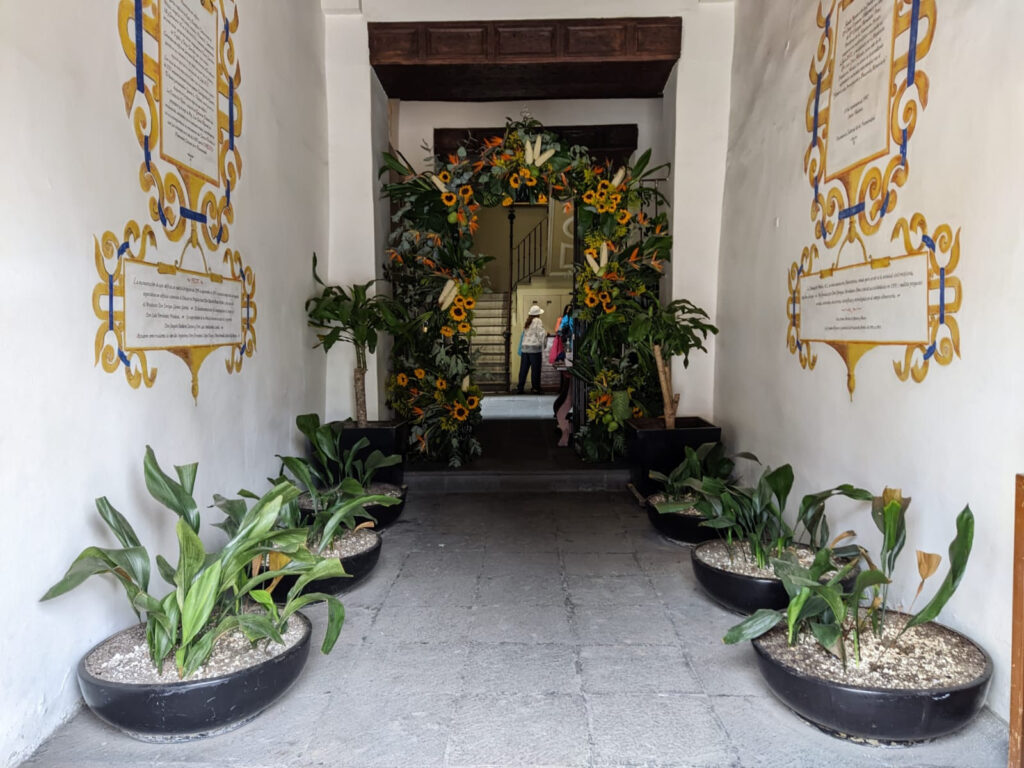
left=398, top=98, right=671, bottom=176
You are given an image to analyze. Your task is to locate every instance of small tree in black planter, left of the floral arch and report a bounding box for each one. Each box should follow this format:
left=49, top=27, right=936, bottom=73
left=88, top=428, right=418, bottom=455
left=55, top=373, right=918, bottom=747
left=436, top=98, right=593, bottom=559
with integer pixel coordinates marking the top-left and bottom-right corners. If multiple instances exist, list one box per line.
left=306, top=254, right=410, bottom=484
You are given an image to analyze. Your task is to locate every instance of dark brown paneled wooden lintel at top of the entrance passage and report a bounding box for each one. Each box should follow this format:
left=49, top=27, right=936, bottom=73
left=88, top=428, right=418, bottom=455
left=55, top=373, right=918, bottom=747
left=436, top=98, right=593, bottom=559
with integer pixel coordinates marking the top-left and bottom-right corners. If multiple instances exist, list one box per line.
left=370, top=16, right=682, bottom=101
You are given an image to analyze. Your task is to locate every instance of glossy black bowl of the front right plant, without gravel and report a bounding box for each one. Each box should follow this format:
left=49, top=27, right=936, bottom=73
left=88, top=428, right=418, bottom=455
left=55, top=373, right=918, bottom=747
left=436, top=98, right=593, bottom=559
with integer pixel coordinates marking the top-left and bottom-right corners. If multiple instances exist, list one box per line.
left=753, top=630, right=992, bottom=742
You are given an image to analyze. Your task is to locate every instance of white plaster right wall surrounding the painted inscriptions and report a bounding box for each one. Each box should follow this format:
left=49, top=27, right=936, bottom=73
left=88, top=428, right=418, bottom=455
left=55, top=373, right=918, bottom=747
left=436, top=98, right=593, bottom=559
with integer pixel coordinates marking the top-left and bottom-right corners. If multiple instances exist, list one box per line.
left=716, top=0, right=1024, bottom=717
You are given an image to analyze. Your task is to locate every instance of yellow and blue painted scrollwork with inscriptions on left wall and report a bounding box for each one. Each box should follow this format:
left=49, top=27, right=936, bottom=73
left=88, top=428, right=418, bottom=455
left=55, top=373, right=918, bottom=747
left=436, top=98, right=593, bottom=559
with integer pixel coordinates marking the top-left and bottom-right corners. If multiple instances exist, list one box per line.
left=93, top=0, right=256, bottom=398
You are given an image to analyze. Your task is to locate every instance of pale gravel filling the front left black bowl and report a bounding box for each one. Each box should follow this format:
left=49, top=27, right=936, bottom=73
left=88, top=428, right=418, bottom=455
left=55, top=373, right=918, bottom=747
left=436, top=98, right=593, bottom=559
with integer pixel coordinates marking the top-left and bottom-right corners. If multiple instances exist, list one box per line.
left=85, top=618, right=305, bottom=685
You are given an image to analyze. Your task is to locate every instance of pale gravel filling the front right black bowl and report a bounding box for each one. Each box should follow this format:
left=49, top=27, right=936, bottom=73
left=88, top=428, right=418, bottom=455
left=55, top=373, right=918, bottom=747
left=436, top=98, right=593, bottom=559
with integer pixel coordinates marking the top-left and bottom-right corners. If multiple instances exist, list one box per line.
left=756, top=612, right=985, bottom=690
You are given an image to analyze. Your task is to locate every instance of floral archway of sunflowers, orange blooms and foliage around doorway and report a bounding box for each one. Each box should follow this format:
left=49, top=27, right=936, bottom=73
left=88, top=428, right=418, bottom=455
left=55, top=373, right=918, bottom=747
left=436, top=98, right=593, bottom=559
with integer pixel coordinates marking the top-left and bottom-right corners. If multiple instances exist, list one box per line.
left=381, top=119, right=672, bottom=466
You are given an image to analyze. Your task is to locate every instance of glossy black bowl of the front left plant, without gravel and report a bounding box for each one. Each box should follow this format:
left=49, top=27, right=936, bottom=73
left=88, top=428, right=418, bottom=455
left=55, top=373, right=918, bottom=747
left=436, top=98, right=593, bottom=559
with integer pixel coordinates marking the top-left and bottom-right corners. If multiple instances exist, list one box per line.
left=78, top=613, right=311, bottom=742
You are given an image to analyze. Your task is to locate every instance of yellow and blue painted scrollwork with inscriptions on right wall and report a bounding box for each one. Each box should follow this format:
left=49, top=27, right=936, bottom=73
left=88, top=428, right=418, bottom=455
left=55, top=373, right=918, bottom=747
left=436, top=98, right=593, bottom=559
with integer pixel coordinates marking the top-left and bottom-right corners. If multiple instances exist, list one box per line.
left=785, top=0, right=962, bottom=398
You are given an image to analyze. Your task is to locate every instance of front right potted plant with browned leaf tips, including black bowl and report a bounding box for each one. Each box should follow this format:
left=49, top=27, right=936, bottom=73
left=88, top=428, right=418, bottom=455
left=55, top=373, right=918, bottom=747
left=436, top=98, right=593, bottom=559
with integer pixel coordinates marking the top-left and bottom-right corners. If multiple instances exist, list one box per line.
left=724, top=489, right=992, bottom=742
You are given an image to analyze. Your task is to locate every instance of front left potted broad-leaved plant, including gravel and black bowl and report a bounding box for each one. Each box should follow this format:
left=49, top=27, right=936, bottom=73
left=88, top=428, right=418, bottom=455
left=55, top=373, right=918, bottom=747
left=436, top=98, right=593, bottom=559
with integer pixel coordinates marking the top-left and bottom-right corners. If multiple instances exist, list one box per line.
left=42, top=446, right=345, bottom=741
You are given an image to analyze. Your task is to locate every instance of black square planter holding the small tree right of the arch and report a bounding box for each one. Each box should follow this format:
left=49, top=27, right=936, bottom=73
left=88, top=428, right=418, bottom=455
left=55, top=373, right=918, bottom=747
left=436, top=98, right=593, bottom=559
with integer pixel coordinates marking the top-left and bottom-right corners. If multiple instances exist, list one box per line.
left=626, top=416, right=722, bottom=496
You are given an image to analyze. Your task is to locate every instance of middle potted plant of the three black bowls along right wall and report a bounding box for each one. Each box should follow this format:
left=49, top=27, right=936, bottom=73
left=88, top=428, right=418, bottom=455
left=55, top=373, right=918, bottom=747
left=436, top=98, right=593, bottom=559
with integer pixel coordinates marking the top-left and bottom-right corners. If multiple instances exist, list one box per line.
left=688, top=464, right=871, bottom=613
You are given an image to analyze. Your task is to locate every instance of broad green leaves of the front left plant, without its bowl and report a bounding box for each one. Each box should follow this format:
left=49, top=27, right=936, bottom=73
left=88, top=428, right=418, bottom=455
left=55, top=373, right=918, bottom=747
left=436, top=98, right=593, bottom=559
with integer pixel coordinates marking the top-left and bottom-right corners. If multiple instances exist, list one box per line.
left=42, top=446, right=345, bottom=678
